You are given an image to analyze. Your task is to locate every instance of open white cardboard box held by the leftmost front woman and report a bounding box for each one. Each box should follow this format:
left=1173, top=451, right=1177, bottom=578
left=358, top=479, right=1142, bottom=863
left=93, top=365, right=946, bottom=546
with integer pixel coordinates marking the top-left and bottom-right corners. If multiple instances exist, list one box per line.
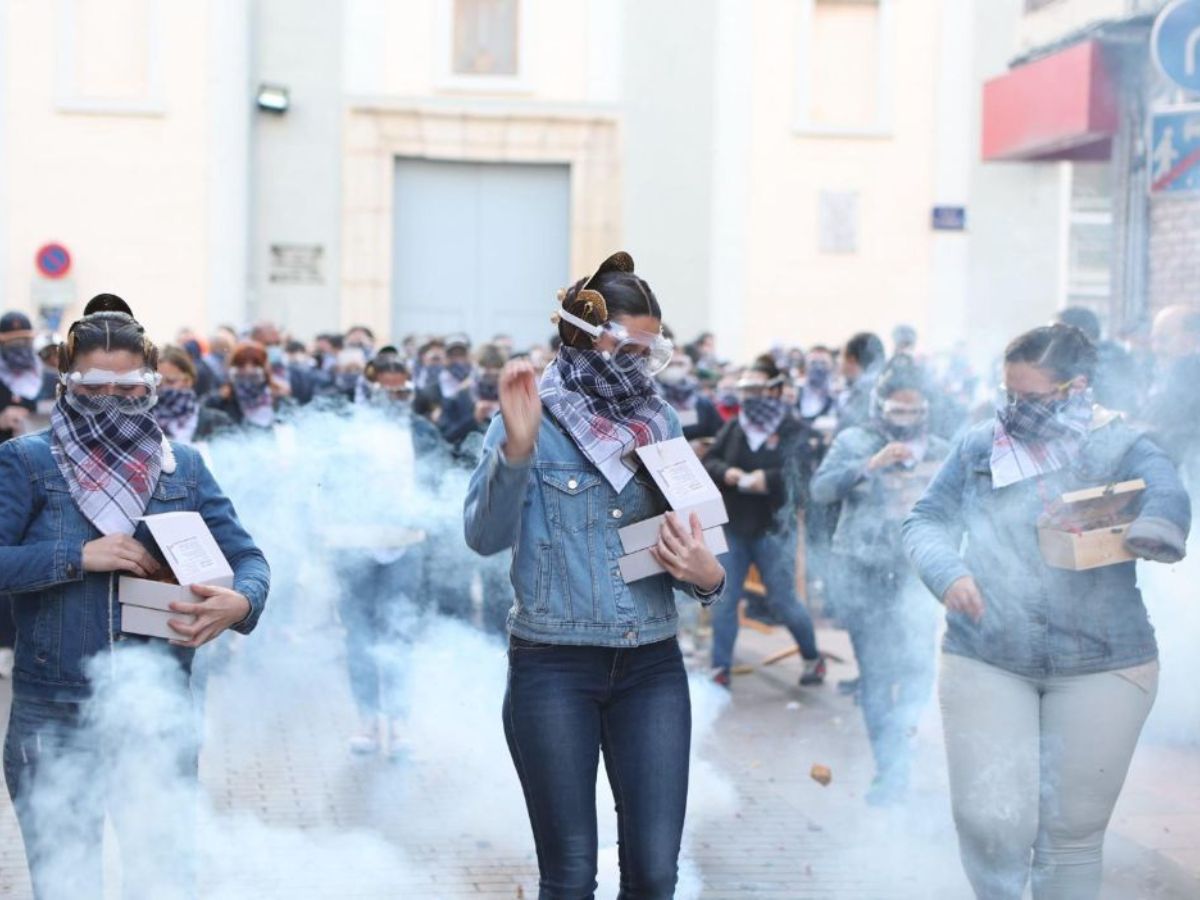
left=116, top=512, right=233, bottom=640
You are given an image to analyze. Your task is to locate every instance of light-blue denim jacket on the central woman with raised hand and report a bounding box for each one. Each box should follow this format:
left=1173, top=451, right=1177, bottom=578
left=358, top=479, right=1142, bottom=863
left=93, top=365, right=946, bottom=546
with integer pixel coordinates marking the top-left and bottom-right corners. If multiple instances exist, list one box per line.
left=463, top=409, right=725, bottom=647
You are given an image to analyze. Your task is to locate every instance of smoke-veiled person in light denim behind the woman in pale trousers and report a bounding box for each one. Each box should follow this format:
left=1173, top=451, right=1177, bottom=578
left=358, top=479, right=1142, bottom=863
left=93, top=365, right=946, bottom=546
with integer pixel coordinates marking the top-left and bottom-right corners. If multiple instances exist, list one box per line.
left=810, top=356, right=949, bottom=804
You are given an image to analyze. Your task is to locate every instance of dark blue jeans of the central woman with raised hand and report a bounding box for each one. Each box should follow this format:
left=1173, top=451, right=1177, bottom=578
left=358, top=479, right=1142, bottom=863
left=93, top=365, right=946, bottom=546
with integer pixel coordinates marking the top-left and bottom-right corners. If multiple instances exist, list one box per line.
left=504, top=637, right=691, bottom=900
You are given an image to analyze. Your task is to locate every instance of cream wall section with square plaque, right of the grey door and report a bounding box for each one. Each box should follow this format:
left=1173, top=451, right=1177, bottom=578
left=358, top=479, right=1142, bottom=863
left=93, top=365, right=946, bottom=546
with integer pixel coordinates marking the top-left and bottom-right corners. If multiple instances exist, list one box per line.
left=718, top=0, right=941, bottom=358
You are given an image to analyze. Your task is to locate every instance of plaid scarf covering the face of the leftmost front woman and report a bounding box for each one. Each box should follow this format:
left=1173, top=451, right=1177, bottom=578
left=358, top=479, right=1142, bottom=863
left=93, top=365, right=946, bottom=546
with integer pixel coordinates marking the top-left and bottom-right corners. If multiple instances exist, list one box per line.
left=50, top=398, right=162, bottom=535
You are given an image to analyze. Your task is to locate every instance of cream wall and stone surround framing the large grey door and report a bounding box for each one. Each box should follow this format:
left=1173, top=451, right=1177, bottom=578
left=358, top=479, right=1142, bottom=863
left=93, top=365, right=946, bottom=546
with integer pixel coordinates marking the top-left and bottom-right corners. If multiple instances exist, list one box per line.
left=341, top=0, right=622, bottom=335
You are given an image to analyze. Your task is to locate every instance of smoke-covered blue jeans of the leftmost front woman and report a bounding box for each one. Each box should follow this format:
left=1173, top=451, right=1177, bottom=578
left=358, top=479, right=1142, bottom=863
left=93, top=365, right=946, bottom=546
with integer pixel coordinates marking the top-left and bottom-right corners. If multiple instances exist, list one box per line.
left=4, top=696, right=198, bottom=900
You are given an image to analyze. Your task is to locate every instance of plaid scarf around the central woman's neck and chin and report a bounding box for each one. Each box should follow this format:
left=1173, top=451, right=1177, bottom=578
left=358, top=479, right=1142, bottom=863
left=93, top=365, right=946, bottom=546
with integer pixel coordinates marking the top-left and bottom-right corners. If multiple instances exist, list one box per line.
left=539, top=347, right=671, bottom=493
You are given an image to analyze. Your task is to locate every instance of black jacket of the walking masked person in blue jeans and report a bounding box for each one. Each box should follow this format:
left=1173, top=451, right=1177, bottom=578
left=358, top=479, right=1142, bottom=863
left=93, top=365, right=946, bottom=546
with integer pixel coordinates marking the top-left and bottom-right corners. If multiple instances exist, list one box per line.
left=704, top=416, right=822, bottom=538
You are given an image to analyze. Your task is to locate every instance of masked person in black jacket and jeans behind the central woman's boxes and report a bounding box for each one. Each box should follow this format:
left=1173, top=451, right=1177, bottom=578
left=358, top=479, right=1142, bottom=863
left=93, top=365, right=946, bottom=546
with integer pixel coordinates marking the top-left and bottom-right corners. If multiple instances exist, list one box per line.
left=704, top=356, right=826, bottom=688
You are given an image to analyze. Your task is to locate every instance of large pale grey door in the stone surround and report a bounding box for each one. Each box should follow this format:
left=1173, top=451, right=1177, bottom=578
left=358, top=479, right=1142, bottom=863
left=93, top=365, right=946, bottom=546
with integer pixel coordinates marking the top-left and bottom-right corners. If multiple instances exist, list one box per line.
left=392, top=158, right=570, bottom=348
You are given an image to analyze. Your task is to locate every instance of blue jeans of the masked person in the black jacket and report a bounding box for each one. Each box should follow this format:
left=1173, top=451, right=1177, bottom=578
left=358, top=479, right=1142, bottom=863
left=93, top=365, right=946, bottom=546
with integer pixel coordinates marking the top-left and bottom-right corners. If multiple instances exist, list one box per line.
left=713, top=529, right=818, bottom=671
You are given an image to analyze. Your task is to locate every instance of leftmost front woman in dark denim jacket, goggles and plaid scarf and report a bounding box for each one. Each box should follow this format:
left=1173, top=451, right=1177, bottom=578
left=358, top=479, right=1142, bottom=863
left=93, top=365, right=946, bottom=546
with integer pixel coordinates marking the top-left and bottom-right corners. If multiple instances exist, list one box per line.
left=0, top=294, right=270, bottom=898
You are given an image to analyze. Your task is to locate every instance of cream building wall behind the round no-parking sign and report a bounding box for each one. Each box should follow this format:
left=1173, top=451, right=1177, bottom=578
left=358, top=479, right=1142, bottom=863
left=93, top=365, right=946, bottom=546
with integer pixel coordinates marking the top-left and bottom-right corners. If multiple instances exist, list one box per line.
left=0, top=0, right=244, bottom=340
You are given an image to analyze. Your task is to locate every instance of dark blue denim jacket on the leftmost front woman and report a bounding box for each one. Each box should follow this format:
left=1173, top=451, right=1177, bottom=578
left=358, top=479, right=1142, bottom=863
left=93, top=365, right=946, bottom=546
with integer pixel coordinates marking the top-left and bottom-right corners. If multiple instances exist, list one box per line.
left=0, top=431, right=270, bottom=702
